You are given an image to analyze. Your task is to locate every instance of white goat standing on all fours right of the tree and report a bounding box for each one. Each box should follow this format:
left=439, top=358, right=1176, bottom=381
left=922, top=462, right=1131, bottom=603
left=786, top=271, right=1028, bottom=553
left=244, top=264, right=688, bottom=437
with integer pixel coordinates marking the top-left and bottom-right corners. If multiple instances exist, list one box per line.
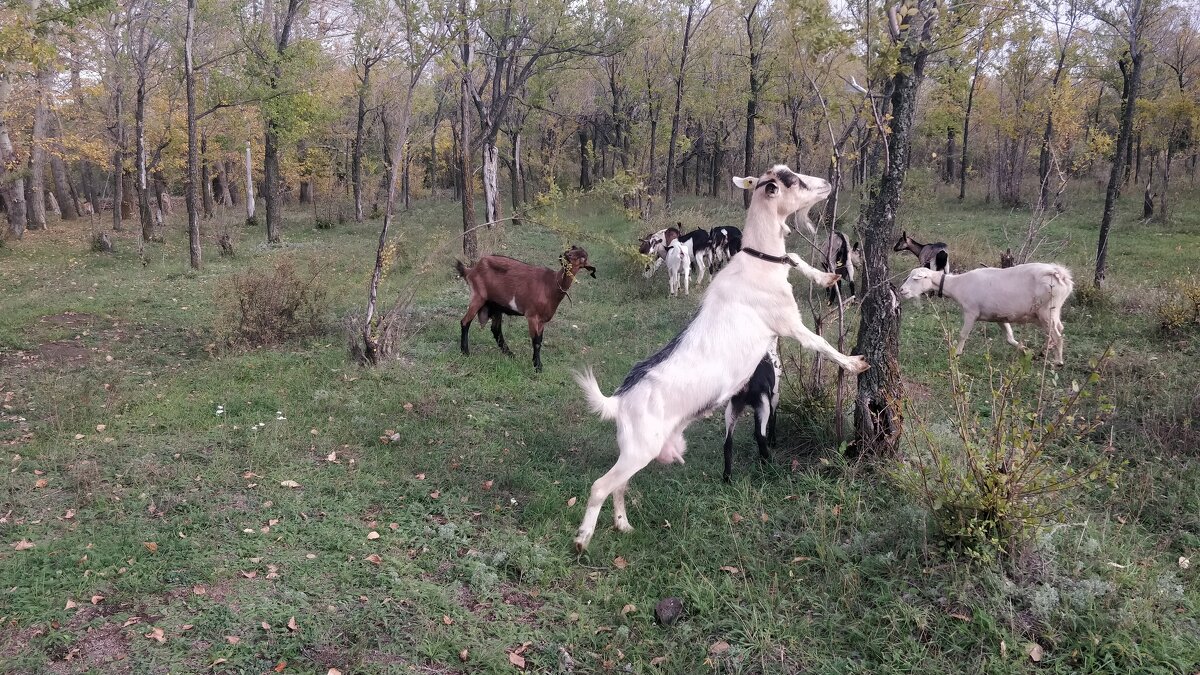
left=900, top=263, right=1075, bottom=365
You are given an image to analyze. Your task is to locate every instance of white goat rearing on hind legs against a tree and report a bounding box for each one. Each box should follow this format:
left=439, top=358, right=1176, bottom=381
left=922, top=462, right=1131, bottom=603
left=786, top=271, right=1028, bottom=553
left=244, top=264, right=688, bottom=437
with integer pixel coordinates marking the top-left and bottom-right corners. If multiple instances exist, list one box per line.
left=575, top=165, right=868, bottom=551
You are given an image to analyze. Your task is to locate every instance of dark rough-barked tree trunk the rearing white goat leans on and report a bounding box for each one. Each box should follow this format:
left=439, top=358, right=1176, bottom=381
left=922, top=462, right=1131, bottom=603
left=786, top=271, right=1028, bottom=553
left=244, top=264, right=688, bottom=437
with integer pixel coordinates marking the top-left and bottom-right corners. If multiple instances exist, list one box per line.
left=854, top=0, right=935, bottom=455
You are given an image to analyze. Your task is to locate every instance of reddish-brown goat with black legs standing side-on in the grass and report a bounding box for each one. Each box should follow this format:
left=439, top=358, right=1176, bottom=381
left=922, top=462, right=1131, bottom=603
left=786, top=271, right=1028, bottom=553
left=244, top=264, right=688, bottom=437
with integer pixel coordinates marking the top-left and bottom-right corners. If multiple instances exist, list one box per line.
left=455, top=246, right=596, bottom=372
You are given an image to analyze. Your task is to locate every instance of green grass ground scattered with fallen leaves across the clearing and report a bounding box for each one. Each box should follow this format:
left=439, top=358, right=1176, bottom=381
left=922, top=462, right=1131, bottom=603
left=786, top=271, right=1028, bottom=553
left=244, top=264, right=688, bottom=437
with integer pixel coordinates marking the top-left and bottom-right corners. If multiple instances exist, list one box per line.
left=0, top=180, right=1200, bottom=673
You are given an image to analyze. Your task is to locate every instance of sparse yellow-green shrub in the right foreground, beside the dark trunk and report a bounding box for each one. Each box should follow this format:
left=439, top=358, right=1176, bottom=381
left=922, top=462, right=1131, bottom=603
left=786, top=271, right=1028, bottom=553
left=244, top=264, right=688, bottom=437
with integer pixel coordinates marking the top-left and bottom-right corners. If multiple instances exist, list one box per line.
left=890, top=343, right=1115, bottom=560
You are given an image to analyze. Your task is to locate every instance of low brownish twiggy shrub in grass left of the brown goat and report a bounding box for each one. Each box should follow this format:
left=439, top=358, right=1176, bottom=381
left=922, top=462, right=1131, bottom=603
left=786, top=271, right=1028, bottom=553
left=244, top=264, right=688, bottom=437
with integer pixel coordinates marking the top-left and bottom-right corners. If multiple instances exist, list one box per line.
left=217, top=257, right=326, bottom=347
